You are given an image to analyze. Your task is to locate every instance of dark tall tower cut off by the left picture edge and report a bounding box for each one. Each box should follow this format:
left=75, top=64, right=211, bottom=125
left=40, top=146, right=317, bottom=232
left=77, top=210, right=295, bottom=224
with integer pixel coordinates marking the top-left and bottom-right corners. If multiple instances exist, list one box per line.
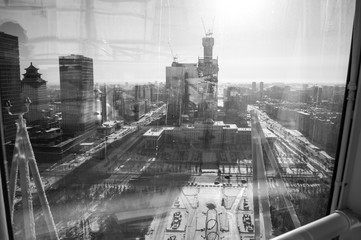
left=0, top=32, right=23, bottom=142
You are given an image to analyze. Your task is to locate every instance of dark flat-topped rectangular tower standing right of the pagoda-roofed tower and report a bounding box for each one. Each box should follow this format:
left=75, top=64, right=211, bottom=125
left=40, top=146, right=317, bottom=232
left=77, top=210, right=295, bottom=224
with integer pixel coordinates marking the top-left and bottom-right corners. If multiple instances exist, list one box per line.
left=59, top=54, right=96, bottom=136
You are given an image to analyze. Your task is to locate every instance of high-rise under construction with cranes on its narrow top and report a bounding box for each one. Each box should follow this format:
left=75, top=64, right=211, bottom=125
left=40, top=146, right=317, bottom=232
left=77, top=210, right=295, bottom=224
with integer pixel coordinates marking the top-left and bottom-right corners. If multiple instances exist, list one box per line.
left=166, top=33, right=218, bottom=125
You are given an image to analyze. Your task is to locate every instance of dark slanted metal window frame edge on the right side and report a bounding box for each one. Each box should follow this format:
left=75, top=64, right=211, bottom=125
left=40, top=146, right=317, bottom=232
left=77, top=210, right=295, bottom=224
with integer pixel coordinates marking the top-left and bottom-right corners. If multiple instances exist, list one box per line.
left=330, top=1, right=361, bottom=213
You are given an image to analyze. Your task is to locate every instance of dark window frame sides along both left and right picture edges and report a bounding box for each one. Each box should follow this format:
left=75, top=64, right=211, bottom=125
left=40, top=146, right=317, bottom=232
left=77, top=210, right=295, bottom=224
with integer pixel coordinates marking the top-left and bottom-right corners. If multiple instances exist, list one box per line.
left=0, top=0, right=361, bottom=240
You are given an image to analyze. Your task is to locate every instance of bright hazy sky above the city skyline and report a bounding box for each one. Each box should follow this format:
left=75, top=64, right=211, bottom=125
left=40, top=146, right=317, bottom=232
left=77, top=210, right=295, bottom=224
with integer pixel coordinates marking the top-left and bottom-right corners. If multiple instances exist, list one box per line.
left=0, top=0, right=354, bottom=84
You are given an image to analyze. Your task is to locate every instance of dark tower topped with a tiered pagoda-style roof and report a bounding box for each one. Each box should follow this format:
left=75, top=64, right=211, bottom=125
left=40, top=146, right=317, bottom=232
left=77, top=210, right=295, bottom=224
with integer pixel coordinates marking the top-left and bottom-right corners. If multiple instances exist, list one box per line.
left=22, top=63, right=48, bottom=123
